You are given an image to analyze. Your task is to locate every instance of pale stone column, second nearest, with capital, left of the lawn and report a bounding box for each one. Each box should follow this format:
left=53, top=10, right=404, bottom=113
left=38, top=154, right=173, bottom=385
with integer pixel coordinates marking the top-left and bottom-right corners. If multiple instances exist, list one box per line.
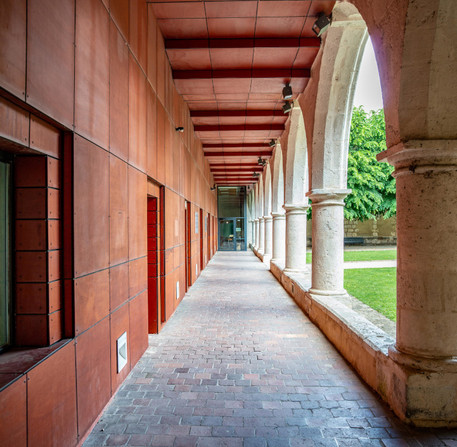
left=309, top=189, right=350, bottom=295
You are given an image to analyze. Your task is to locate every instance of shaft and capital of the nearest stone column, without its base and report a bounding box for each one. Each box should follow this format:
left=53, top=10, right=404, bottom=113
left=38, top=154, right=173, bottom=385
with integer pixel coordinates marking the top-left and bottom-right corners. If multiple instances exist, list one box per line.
left=388, top=147, right=457, bottom=358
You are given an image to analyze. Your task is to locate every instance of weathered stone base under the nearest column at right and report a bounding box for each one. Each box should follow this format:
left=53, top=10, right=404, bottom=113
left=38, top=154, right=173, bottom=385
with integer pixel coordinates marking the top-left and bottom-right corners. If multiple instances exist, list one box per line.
left=380, top=347, right=457, bottom=427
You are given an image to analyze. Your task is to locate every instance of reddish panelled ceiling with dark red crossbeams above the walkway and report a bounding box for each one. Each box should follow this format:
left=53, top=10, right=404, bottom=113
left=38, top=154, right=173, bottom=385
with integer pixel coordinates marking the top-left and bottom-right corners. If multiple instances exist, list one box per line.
left=148, top=0, right=335, bottom=185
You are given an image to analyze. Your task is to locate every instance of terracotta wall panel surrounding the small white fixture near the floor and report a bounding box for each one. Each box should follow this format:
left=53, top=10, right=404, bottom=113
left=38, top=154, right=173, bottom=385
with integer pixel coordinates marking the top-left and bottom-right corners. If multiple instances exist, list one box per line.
left=110, top=304, right=131, bottom=394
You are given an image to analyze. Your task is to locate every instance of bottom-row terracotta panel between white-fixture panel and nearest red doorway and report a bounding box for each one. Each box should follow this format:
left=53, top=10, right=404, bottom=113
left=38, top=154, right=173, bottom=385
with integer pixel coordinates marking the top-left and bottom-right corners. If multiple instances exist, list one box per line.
left=129, top=291, right=148, bottom=366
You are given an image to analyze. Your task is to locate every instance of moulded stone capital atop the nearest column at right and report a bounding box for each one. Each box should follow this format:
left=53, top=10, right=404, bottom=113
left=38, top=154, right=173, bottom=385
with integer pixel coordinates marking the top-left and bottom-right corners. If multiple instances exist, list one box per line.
left=376, top=140, right=457, bottom=177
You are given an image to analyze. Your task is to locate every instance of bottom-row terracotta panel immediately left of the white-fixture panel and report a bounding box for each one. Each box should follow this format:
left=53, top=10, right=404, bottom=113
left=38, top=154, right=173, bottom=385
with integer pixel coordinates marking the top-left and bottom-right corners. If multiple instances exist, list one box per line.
left=76, top=318, right=111, bottom=437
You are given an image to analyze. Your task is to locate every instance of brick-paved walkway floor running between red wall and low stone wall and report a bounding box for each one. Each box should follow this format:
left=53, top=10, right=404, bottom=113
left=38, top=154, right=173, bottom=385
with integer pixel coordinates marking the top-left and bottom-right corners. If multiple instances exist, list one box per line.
left=84, top=252, right=457, bottom=447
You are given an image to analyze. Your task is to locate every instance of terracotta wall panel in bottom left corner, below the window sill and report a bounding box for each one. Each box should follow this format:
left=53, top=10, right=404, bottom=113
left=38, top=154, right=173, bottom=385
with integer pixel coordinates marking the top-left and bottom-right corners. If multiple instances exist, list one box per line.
left=0, top=377, right=27, bottom=447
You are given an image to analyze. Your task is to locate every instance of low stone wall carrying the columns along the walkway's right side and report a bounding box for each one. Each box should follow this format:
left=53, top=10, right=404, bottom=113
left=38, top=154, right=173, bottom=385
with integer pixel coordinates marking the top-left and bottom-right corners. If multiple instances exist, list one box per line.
left=260, top=250, right=457, bottom=427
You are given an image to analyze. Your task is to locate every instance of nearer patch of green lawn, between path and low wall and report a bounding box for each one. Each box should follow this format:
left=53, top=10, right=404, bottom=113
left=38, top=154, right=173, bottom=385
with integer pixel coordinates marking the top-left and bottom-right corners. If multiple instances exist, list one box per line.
left=344, top=268, right=397, bottom=321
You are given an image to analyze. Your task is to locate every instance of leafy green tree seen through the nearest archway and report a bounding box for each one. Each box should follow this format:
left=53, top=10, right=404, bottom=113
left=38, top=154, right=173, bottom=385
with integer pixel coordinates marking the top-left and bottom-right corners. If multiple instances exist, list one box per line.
left=344, top=106, right=396, bottom=220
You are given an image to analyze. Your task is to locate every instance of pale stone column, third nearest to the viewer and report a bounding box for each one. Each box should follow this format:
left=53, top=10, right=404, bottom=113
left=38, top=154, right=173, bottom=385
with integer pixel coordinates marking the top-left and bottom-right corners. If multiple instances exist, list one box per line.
left=283, top=204, right=309, bottom=272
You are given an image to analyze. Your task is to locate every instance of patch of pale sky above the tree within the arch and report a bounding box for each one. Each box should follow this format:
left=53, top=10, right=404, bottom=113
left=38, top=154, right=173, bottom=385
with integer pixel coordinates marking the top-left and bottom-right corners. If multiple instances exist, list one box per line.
left=354, top=39, right=383, bottom=111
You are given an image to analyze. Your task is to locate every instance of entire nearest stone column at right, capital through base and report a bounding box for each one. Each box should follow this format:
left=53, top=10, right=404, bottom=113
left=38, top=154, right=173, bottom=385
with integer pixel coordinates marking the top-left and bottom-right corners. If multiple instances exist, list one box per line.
left=380, top=144, right=457, bottom=426
